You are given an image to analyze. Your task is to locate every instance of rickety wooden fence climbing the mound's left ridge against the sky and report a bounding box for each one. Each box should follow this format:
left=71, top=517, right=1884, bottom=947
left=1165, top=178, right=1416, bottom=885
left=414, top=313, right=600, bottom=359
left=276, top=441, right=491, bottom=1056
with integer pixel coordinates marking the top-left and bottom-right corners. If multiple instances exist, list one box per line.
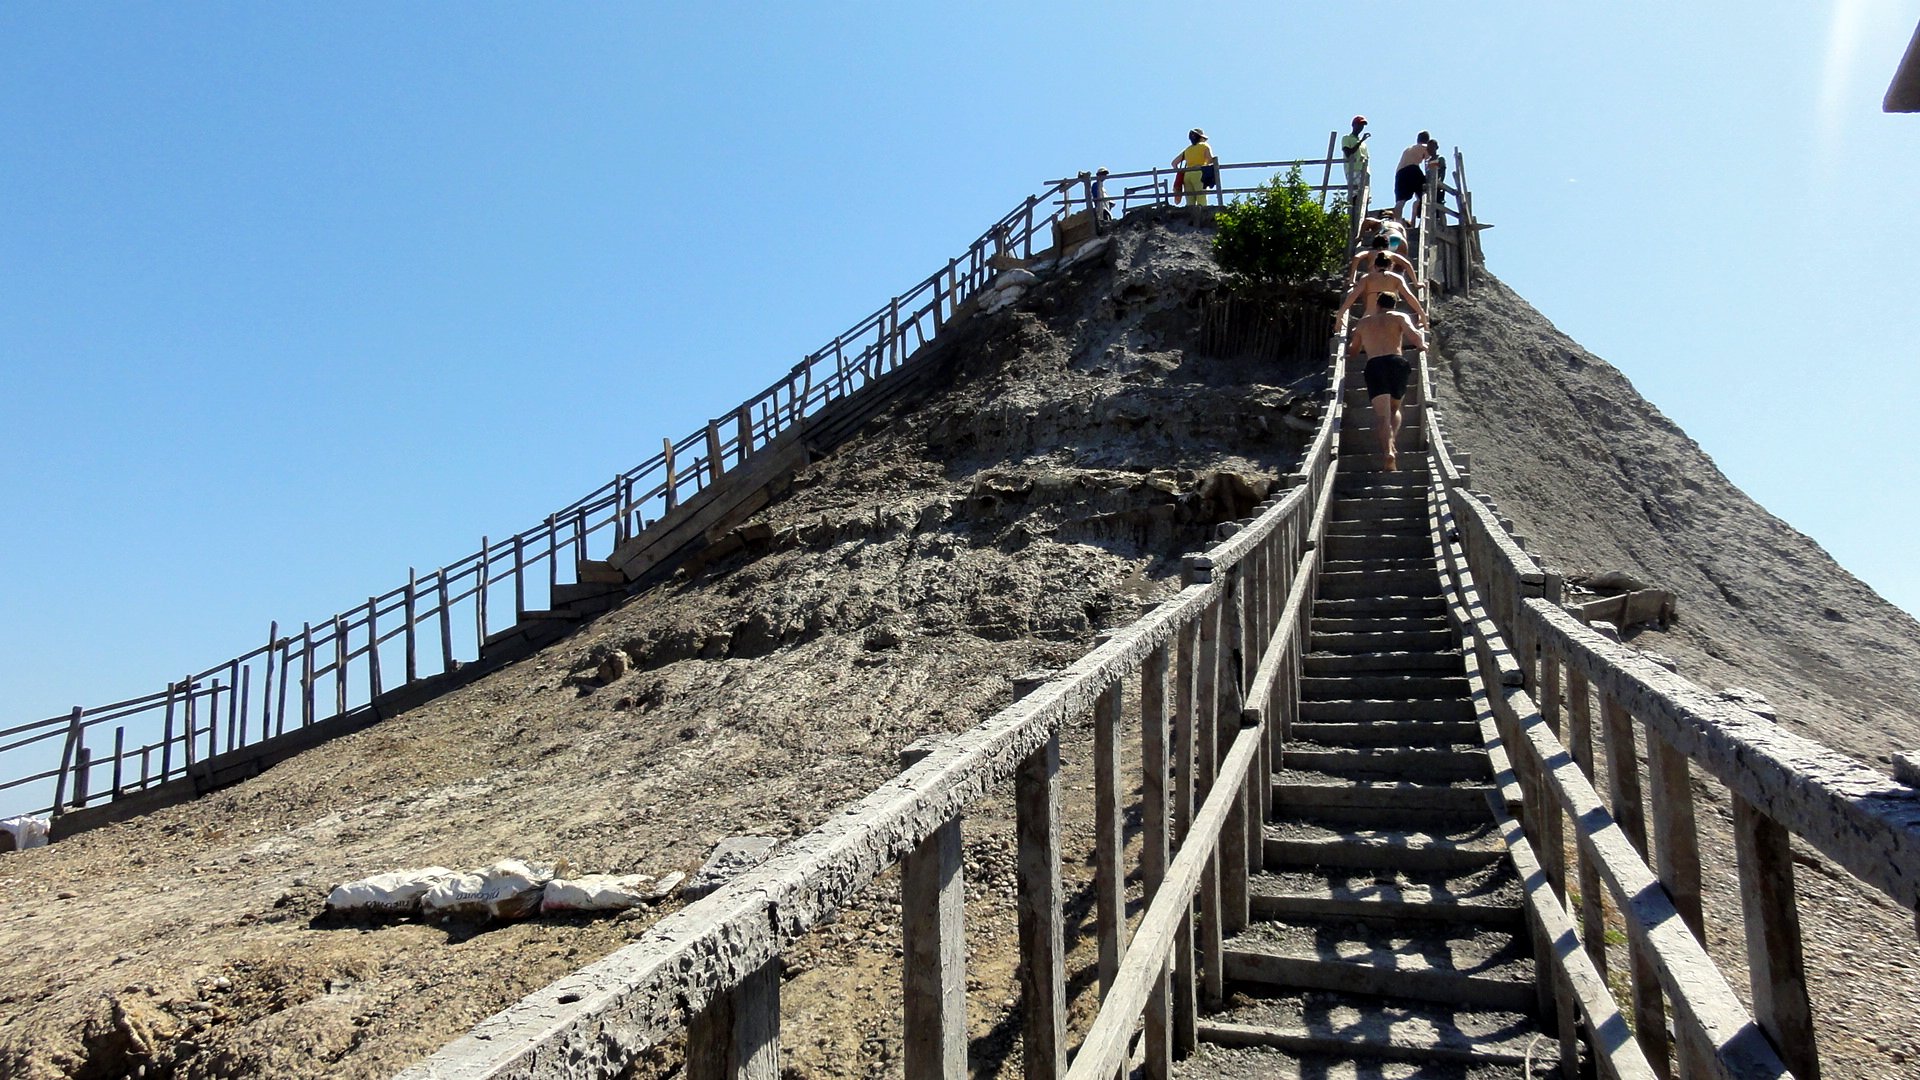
left=0, top=148, right=1331, bottom=832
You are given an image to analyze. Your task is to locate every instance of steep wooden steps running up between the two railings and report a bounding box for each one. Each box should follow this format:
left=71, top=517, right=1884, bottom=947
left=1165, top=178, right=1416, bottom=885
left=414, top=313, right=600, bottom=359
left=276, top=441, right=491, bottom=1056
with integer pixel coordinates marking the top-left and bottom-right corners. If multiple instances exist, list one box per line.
left=1179, top=367, right=1561, bottom=1080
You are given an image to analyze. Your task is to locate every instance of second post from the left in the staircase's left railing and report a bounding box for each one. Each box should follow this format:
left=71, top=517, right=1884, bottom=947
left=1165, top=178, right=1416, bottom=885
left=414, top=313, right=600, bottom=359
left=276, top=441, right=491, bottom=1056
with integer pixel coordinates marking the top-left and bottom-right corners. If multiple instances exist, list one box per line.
left=900, top=740, right=966, bottom=1080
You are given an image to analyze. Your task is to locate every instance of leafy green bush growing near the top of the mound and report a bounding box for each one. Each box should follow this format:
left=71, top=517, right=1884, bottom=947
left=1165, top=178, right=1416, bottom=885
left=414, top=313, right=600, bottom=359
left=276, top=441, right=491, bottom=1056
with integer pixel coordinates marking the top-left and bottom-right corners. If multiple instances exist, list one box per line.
left=1213, top=165, right=1350, bottom=284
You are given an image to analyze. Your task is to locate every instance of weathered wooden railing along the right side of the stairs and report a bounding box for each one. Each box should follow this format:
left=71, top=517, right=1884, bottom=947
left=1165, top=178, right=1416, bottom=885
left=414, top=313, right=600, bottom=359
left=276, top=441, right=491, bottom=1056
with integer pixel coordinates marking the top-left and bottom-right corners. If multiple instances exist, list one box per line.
left=1421, top=253, right=1920, bottom=1080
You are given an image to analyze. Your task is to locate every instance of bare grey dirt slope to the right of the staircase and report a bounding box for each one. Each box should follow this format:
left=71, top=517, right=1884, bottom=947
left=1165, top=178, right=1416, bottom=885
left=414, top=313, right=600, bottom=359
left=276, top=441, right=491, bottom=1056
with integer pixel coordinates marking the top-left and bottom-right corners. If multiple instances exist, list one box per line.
left=1434, top=272, right=1920, bottom=1080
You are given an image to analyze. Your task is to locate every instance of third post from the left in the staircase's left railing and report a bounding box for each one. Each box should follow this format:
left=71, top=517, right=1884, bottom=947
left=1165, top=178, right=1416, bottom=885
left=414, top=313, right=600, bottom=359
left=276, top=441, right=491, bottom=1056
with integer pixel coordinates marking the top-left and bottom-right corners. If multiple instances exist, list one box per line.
left=1014, top=664, right=1068, bottom=1080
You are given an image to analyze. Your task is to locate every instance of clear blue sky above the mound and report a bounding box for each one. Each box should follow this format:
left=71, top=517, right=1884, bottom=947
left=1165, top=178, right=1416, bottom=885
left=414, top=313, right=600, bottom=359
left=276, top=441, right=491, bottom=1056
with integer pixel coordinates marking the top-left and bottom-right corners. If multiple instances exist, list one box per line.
left=0, top=0, right=1920, bottom=726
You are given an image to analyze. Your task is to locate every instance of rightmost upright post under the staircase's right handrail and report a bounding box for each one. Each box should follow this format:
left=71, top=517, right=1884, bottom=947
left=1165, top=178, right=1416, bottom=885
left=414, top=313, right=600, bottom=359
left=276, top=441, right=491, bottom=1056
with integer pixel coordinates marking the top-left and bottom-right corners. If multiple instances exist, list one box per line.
left=1732, top=794, right=1820, bottom=1080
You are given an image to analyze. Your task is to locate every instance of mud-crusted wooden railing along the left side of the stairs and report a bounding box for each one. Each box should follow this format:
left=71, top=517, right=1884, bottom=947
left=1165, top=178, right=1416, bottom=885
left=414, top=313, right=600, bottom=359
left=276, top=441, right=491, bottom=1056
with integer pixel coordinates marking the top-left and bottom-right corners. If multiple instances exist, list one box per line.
left=389, top=274, right=1346, bottom=1080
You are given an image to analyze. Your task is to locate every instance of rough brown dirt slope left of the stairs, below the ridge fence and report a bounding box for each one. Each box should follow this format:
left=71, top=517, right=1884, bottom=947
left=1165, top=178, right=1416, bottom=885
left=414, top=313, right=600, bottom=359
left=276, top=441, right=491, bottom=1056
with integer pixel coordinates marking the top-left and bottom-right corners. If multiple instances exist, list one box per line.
left=0, top=219, right=1321, bottom=1078
